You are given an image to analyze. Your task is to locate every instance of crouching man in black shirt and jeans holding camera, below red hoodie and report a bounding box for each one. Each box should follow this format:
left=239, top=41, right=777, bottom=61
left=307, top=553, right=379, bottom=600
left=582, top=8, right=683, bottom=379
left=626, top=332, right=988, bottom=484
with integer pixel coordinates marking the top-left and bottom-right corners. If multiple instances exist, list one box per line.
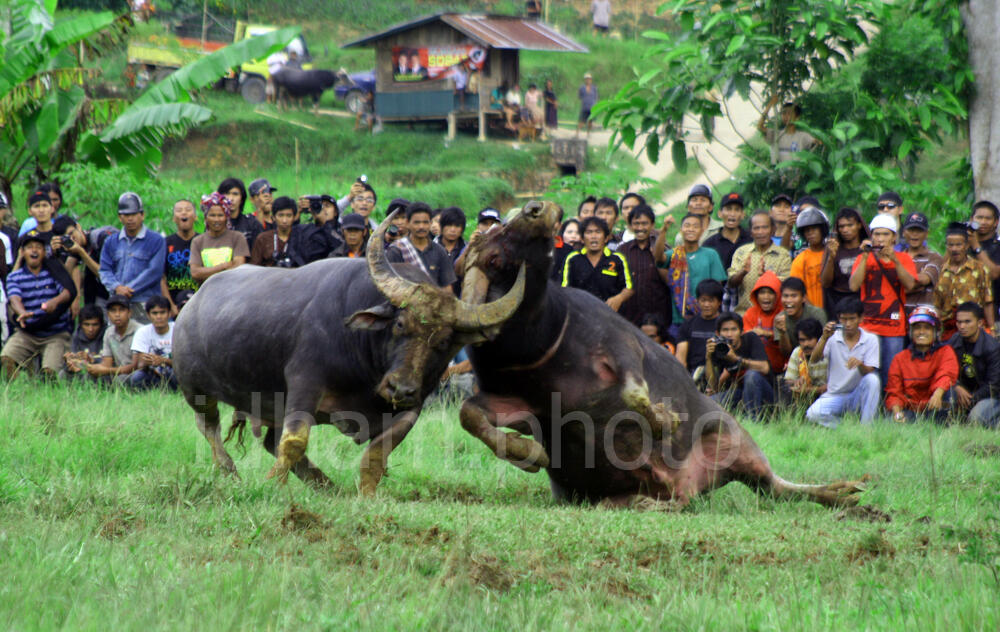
left=705, top=312, right=774, bottom=421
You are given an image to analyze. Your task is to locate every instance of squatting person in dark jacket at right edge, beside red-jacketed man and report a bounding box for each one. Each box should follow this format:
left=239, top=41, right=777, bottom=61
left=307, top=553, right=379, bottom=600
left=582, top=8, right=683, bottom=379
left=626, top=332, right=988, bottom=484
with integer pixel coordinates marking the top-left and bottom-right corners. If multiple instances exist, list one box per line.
left=948, top=302, right=1000, bottom=428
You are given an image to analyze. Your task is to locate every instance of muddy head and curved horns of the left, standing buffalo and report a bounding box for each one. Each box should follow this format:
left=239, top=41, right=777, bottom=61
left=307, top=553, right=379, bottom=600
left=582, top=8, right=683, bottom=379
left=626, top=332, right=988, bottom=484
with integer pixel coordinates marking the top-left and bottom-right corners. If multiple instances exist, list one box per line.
left=346, top=211, right=524, bottom=408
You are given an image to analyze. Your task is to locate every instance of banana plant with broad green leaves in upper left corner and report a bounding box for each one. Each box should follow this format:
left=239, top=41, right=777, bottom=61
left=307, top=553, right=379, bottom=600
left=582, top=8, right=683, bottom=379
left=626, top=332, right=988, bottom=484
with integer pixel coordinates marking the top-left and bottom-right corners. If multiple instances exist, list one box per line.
left=0, top=0, right=300, bottom=202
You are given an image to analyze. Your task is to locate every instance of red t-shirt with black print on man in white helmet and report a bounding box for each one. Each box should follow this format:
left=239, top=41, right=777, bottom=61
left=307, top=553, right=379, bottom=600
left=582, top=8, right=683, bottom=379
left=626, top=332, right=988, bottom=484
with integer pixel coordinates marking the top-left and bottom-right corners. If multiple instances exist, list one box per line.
left=852, top=252, right=917, bottom=340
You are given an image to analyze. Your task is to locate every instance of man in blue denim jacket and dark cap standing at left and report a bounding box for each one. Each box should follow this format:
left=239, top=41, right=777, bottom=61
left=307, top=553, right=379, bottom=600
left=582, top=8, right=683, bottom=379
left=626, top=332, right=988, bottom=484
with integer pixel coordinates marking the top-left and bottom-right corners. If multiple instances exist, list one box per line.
left=101, top=192, right=167, bottom=324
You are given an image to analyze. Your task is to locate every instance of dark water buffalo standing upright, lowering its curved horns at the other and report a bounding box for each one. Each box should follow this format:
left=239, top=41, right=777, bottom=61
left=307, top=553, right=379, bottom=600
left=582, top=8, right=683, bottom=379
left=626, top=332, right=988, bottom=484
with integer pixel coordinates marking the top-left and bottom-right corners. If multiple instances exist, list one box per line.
left=174, top=216, right=524, bottom=494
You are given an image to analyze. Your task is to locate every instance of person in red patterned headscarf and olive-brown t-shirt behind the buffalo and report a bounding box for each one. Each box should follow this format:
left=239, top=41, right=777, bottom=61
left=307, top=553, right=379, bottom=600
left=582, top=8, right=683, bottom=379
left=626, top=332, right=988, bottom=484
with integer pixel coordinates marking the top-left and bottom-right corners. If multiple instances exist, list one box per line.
left=190, top=193, right=250, bottom=284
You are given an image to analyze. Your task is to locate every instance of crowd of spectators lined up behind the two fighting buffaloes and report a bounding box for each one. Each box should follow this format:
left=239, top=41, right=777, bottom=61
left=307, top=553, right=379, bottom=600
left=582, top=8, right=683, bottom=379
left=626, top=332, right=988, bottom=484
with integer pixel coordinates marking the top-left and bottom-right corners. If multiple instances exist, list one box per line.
left=0, top=176, right=1000, bottom=427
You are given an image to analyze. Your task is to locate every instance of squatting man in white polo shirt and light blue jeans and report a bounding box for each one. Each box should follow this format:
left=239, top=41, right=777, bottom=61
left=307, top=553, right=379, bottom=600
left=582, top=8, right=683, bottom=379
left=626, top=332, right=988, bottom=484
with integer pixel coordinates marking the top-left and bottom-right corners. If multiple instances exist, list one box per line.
left=806, top=297, right=882, bottom=428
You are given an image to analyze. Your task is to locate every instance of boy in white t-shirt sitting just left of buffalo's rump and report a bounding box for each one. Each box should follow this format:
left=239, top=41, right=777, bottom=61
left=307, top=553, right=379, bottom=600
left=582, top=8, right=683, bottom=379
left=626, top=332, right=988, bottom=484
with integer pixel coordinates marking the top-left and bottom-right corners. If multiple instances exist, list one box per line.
left=128, top=296, right=177, bottom=391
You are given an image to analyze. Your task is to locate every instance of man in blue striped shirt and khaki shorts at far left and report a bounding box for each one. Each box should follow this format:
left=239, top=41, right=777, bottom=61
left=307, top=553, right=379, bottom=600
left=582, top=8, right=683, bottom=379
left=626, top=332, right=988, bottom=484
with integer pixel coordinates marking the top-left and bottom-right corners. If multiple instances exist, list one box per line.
left=0, top=233, right=76, bottom=378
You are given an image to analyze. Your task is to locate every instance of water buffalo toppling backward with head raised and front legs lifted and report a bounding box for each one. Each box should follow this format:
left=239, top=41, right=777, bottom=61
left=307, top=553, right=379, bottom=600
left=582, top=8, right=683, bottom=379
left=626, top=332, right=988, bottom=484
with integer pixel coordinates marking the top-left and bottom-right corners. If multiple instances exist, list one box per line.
left=460, top=202, right=862, bottom=507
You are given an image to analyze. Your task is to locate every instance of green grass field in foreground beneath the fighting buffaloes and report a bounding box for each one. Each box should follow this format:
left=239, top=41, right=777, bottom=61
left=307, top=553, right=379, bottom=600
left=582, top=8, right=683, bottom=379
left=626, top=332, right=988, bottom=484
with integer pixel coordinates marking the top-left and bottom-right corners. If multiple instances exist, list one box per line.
left=0, top=379, right=1000, bottom=630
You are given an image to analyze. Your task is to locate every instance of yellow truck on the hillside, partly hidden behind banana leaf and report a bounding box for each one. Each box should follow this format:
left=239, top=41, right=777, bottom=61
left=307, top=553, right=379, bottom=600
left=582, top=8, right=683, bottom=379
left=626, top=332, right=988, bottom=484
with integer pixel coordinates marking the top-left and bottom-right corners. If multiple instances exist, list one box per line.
left=128, top=15, right=312, bottom=103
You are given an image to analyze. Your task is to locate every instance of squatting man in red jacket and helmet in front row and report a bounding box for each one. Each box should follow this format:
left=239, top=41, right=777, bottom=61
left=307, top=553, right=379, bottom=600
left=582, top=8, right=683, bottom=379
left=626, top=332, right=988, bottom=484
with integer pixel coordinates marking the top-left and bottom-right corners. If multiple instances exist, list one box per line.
left=885, top=305, right=958, bottom=423
